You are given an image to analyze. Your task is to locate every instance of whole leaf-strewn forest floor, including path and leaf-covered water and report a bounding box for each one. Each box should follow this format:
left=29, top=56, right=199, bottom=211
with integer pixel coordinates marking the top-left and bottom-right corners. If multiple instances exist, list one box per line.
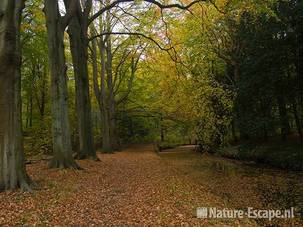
left=0, top=145, right=303, bottom=226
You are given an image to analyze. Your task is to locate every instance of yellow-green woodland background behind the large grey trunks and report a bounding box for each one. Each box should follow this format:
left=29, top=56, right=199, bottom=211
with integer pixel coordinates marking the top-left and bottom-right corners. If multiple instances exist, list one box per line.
left=21, top=0, right=303, bottom=161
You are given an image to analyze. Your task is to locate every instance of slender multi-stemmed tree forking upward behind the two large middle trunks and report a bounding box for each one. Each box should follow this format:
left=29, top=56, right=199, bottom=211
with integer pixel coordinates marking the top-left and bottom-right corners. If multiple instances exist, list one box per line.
left=91, top=12, right=144, bottom=152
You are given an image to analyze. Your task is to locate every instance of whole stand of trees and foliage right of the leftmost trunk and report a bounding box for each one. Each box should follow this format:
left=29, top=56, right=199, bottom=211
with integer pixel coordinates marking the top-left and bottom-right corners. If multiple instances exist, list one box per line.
left=1, top=0, right=303, bottom=191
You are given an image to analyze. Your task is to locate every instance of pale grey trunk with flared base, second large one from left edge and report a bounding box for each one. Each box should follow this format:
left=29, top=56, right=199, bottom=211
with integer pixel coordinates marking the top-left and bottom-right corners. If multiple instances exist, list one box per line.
left=45, top=0, right=79, bottom=168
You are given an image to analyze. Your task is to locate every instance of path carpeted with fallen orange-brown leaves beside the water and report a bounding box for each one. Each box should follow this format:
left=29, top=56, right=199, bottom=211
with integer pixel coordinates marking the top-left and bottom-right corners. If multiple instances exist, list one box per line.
left=0, top=145, right=302, bottom=226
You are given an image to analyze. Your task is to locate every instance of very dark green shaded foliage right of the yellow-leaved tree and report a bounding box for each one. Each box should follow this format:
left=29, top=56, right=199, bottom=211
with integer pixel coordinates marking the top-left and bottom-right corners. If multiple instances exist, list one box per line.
left=233, top=1, right=302, bottom=137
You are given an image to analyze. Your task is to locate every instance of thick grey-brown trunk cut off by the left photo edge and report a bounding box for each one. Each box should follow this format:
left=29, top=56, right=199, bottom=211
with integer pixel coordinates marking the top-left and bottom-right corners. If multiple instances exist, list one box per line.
left=0, top=0, right=31, bottom=190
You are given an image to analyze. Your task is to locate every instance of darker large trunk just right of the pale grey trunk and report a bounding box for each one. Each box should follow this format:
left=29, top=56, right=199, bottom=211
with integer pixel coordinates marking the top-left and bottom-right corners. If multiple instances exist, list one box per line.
left=66, top=1, right=97, bottom=160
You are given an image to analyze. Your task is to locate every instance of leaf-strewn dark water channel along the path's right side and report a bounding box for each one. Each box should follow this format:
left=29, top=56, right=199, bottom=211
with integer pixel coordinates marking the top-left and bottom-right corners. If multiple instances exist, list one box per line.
left=160, top=146, right=303, bottom=225
